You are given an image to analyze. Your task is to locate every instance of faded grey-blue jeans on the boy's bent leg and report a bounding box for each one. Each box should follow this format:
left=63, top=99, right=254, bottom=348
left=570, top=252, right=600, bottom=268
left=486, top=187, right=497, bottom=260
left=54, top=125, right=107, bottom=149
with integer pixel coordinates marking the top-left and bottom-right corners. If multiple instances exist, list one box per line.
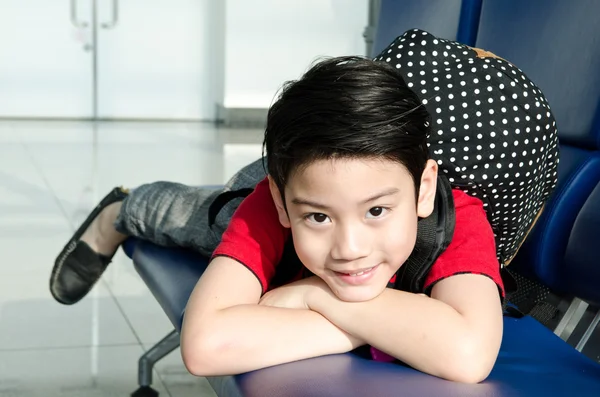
left=114, top=159, right=267, bottom=256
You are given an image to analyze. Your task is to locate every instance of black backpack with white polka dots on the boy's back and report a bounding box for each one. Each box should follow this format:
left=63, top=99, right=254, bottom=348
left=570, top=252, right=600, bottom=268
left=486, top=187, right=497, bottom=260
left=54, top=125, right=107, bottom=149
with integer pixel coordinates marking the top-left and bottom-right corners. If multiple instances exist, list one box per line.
left=375, top=29, right=558, bottom=290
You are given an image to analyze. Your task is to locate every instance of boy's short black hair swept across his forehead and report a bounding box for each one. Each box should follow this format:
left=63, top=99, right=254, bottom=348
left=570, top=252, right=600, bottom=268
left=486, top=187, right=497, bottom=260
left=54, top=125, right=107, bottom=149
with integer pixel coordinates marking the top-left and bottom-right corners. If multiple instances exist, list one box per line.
left=263, top=56, right=429, bottom=201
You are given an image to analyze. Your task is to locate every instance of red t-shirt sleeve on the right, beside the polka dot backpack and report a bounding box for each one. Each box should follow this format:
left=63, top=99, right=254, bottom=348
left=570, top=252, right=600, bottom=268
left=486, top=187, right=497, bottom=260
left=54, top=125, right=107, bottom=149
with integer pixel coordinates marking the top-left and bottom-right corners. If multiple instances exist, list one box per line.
left=425, top=189, right=504, bottom=297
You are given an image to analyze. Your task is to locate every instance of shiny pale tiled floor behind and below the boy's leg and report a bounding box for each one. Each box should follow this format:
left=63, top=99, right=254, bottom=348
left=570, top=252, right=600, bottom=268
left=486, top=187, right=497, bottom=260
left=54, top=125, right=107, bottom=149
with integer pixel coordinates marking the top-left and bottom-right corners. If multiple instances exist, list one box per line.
left=0, top=121, right=262, bottom=397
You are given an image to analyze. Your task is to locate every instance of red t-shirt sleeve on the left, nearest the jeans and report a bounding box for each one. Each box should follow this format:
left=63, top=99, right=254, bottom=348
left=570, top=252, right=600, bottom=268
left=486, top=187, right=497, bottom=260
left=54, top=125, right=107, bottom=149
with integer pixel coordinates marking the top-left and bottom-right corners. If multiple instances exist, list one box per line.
left=212, top=178, right=289, bottom=292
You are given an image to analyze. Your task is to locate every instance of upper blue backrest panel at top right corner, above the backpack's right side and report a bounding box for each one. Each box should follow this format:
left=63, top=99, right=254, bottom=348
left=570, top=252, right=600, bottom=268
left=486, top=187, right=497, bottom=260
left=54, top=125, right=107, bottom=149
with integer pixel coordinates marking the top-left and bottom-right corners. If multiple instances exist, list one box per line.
left=476, top=0, right=600, bottom=142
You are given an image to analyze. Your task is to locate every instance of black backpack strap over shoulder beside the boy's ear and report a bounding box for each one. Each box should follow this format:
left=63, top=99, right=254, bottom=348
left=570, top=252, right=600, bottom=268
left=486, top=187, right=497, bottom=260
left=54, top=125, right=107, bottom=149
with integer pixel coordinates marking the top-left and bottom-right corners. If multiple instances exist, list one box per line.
left=394, top=175, right=456, bottom=293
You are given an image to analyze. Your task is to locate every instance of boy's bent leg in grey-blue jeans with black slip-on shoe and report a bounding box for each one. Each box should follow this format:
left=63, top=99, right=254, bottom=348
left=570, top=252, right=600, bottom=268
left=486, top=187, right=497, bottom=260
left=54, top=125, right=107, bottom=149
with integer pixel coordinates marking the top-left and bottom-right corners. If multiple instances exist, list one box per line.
left=50, top=159, right=266, bottom=304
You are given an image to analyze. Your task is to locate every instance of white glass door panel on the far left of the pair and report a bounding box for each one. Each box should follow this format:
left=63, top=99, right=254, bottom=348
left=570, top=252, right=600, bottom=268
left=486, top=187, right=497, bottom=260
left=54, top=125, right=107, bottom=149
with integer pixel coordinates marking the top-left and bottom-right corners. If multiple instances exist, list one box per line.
left=0, top=0, right=94, bottom=119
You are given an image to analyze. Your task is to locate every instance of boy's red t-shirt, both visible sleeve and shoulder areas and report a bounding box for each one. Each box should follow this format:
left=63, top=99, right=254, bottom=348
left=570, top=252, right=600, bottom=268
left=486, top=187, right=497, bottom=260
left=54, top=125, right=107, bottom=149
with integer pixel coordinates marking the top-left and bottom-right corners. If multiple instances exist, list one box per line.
left=213, top=178, right=504, bottom=296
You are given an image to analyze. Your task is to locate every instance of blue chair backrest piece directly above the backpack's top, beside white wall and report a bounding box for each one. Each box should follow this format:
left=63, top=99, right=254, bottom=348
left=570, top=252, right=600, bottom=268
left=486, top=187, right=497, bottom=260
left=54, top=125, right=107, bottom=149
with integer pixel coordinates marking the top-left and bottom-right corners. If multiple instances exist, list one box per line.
left=369, top=0, right=481, bottom=56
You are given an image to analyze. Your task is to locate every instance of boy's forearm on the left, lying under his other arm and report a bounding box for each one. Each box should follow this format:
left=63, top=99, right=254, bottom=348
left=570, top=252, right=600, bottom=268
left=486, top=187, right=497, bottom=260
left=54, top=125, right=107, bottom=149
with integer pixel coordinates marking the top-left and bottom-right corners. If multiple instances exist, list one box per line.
left=188, top=305, right=362, bottom=376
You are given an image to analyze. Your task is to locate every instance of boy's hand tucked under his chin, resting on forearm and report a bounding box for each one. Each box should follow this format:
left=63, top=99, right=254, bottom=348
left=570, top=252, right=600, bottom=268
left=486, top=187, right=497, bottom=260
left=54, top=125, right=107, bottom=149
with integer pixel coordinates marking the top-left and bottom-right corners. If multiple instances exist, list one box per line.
left=259, top=276, right=329, bottom=309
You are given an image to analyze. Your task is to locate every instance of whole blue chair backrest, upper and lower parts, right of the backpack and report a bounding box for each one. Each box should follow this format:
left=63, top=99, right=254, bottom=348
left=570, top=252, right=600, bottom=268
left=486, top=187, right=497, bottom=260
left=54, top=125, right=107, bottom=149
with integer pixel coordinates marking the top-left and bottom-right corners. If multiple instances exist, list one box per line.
left=475, top=0, right=600, bottom=301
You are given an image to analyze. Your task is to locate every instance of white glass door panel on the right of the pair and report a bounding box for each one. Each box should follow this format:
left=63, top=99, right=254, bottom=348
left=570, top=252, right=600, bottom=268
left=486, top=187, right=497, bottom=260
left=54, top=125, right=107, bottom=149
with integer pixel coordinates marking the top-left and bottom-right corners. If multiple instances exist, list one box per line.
left=97, top=0, right=225, bottom=120
